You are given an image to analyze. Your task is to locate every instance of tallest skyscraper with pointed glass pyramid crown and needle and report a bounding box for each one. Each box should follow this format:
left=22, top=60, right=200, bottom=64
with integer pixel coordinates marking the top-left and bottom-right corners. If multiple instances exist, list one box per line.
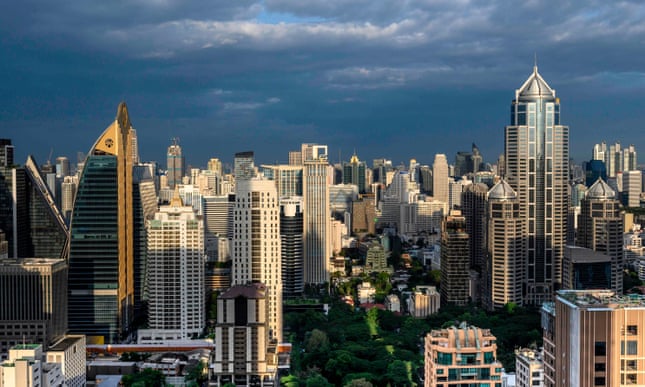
left=505, top=66, right=569, bottom=304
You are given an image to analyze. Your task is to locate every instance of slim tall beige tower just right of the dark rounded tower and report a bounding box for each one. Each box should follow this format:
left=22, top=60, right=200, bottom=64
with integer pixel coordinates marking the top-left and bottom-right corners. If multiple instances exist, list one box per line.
left=302, top=144, right=331, bottom=284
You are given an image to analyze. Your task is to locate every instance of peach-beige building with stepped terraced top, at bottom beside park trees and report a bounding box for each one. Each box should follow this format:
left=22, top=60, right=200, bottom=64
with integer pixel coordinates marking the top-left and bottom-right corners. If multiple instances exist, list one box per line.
left=424, top=323, right=502, bottom=387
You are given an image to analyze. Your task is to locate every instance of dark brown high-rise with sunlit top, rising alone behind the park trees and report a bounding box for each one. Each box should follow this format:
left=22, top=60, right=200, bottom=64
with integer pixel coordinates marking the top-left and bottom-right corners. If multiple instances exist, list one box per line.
left=441, top=210, right=470, bottom=306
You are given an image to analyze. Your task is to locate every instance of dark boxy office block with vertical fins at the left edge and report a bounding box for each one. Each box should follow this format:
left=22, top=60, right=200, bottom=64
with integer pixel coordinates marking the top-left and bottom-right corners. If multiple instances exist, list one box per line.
left=0, top=258, right=67, bottom=362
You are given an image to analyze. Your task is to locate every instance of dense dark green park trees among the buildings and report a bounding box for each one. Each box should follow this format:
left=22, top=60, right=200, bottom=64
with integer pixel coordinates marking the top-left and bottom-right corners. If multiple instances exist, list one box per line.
left=281, top=298, right=541, bottom=387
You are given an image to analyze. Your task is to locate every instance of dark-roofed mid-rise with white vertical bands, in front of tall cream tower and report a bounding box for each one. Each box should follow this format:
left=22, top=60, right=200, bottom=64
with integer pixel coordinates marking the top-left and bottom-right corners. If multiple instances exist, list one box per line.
left=209, top=282, right=277, bottom=386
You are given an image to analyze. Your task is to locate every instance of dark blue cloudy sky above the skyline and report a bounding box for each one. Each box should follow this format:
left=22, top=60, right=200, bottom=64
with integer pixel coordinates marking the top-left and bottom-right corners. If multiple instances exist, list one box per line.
left=0, top=0, right=645, bottom=167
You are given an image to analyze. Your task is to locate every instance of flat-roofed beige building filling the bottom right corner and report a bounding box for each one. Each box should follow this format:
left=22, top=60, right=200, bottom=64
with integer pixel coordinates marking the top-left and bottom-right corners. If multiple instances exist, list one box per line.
left=542, top=290, right=645, bottom=387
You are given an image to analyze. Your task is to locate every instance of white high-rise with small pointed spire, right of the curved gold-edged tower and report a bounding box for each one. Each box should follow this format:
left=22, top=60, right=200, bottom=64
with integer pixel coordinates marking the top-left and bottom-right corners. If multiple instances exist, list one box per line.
left=145, top=187, right=205, bottom=340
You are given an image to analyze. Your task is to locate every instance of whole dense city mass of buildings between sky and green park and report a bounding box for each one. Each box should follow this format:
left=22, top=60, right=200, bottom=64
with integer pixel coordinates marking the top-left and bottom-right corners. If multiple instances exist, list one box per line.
left=0, top=67, right=645, bottom=386
